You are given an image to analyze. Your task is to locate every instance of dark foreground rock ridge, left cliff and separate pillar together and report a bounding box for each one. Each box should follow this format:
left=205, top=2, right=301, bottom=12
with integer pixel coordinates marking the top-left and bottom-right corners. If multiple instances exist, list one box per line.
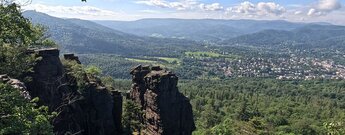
left=0, top=48, right=195, bottom=135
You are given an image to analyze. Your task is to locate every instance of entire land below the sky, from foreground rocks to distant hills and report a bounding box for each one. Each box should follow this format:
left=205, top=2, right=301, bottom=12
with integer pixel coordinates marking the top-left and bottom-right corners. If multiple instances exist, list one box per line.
left=0, top=5, right=345, bottom=135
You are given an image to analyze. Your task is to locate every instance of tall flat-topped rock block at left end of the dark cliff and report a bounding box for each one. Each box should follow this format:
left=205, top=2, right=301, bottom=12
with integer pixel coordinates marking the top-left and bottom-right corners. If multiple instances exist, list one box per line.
left=27, top=48, right=69, bottom=108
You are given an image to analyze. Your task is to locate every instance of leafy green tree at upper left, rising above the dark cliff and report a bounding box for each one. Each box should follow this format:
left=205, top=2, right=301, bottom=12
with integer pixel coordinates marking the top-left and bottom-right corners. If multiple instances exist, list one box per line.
left=0, top=4, right=56, bottom=79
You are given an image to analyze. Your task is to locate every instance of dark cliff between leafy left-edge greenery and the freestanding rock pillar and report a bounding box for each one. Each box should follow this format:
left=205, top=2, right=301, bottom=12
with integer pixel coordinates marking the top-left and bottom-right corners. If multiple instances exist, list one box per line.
left=27, top=49, right=122, bottom=135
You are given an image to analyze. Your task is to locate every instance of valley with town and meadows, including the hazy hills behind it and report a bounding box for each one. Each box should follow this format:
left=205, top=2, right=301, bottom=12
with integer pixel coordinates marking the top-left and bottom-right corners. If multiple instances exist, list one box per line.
left=24, top=11, right=345, bottom=80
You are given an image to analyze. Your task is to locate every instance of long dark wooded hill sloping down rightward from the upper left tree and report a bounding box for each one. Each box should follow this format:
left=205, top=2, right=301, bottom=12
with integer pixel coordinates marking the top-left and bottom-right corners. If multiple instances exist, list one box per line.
left=23, top=11, right=196, bottom=56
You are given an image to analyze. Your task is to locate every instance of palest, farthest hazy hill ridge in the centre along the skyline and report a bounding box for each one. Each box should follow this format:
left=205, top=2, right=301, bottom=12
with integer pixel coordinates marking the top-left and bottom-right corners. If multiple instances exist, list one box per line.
left=94, top=19, right=305, bottom=41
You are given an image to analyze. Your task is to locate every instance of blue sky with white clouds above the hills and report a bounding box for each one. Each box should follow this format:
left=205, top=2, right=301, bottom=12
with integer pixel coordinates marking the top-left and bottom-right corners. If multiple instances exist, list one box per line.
left=23, top=0, right=345, bottom=25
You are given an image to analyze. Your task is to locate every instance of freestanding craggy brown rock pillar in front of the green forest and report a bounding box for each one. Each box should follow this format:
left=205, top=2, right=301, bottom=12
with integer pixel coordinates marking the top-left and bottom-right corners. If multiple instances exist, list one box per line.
left=130, top=65, right=195, bottom=135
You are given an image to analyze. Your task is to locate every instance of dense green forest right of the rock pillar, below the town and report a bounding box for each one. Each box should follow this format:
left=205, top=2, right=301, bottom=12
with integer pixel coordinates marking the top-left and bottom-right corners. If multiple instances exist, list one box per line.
left=104, top=78, right=345, bottom=135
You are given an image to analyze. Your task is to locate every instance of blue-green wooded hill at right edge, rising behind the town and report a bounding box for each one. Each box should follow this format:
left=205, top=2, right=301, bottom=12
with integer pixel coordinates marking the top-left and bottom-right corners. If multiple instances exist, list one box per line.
left=220, top=24, right=345, bottom=48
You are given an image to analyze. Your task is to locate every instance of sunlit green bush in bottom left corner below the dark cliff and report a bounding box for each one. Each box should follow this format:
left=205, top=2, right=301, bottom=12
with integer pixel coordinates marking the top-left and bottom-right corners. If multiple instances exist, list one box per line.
left=0, top=83, right=53, bottom=135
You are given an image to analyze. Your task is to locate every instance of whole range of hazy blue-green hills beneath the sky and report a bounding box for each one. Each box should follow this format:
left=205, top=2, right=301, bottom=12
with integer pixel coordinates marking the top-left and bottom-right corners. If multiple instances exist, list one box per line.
left=23, top=11, right=345, bottom=53
